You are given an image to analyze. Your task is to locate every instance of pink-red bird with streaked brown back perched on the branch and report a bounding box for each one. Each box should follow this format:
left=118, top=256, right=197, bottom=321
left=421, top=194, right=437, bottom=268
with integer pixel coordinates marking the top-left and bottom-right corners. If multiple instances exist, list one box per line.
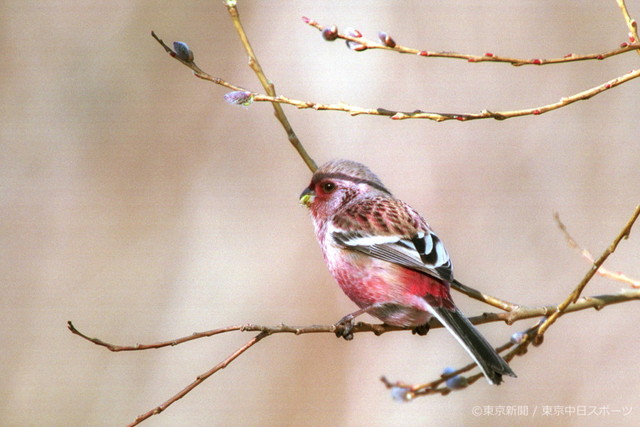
left=300, top=159, right=516, bottom=385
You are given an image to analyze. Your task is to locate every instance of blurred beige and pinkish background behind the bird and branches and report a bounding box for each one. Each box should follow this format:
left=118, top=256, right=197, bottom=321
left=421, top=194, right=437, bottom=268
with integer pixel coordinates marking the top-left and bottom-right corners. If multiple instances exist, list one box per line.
left=0, top=0, right=640, bottom=426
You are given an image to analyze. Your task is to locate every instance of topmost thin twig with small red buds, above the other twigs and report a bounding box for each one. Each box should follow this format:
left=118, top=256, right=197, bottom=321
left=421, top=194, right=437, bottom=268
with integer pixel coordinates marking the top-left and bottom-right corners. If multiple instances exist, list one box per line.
left=302, top=16, right=640, bottom=67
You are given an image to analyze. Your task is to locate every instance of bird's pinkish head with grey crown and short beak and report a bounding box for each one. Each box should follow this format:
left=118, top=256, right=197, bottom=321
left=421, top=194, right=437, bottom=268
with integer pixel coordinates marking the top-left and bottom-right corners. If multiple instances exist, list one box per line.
left=300, top=160, right=391, bottom=218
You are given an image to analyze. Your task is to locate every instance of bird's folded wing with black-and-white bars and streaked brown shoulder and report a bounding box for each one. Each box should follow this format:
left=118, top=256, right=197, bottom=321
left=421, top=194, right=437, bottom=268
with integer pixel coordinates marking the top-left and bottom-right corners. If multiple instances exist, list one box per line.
left=327, top=197, right=453, bottom=282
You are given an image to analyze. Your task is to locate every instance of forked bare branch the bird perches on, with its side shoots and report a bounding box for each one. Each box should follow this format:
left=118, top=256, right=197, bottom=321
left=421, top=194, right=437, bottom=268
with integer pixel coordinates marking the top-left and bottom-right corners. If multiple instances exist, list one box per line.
left=67, top=205, right=640, bottom=412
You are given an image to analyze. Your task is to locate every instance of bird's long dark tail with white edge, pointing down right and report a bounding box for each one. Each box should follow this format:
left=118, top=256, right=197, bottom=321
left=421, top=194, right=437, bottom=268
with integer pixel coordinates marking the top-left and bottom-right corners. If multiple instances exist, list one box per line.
left=432, top=307, right=516, bottom=385
